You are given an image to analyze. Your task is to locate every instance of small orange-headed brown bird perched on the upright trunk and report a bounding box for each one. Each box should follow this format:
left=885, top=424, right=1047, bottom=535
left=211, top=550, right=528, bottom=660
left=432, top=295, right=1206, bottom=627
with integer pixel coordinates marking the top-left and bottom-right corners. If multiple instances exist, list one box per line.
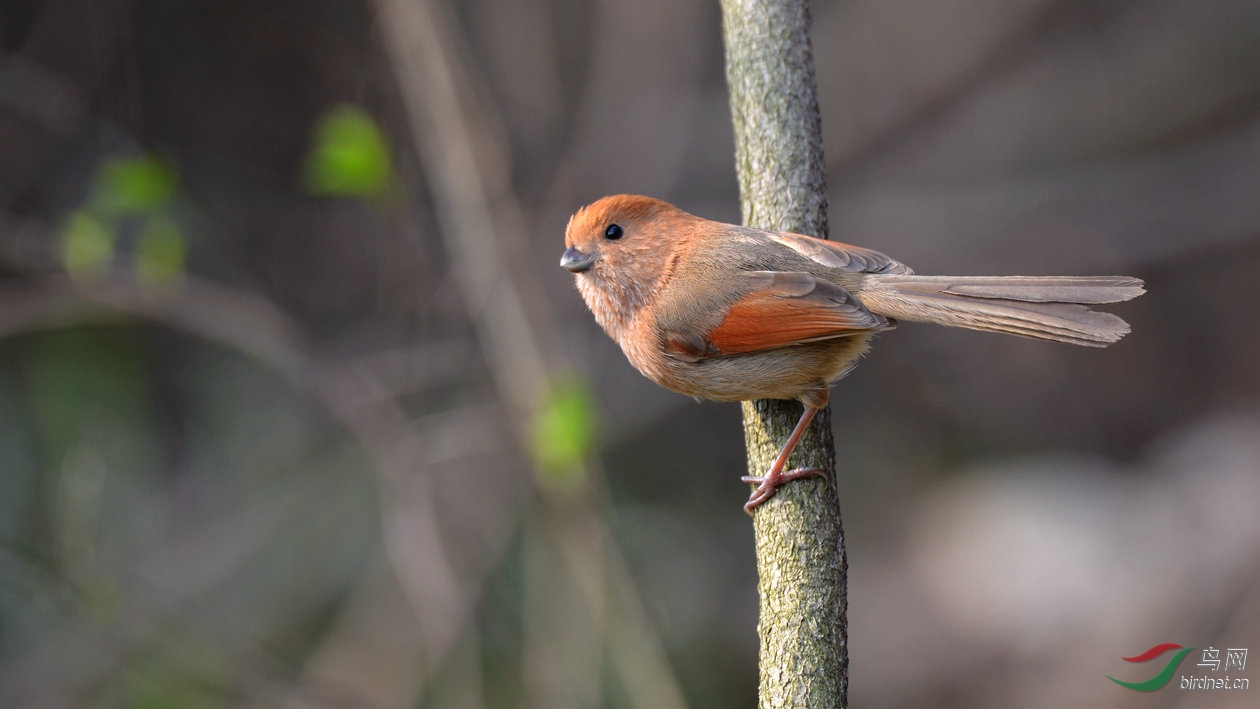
left=559, top=195, right=1144, bottom=514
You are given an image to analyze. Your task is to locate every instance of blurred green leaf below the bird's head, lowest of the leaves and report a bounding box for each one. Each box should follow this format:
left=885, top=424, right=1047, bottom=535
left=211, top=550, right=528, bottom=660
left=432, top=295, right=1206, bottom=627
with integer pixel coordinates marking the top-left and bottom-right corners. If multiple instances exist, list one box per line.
left=532, top=379, right=596, bottom=492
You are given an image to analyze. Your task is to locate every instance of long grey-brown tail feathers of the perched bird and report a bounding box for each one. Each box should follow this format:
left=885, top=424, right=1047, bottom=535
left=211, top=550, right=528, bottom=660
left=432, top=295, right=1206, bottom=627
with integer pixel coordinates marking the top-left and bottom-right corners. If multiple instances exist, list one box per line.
left=861, top=273, right=1145, bottom=348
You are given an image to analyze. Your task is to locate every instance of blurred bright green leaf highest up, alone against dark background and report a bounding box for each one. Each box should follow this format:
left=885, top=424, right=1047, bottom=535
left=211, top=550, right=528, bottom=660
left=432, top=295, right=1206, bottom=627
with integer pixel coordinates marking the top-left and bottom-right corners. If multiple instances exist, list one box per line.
left=305, top=105, right=393, bottom=198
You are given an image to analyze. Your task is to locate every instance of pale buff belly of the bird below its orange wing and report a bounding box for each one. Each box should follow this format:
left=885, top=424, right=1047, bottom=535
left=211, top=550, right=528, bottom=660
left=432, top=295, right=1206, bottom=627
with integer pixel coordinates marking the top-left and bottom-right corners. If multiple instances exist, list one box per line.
left=636, top=334, right=871, bottom=402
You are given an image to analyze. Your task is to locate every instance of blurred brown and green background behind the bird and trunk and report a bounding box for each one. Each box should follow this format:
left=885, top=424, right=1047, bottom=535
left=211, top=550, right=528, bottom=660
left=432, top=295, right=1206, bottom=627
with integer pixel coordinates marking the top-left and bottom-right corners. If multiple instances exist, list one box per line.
left=0, top=0, right=1260, bottom=709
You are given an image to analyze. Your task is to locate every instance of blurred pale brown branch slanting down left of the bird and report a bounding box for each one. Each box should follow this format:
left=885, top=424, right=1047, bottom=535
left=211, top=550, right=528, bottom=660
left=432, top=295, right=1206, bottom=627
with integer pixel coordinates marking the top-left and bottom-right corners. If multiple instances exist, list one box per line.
left=379, top=0, right=685, bottom=709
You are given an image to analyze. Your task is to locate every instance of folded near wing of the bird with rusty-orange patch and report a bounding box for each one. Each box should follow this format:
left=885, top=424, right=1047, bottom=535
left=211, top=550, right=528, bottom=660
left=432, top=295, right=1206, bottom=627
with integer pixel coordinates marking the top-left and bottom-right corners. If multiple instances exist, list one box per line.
left=662, top=271, right=895, bottom=361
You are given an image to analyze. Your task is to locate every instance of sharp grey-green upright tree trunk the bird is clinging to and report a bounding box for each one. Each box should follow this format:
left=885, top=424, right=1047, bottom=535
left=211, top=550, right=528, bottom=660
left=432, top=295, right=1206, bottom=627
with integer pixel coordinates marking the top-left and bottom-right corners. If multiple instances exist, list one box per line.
left=722, top=0, right=848, bottom=709
